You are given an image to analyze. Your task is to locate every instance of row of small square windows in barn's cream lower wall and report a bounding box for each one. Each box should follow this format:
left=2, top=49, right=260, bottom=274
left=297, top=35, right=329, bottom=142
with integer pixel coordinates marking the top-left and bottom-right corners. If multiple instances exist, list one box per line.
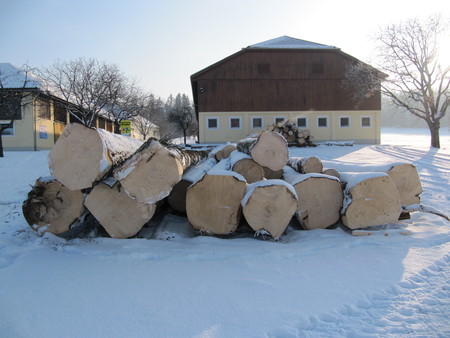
left=207, top=116, right=372, bottom=129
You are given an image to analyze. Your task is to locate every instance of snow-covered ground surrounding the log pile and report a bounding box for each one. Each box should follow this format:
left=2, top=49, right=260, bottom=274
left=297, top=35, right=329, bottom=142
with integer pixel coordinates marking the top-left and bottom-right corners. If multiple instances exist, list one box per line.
left=0, top=130, right=450, bottom=338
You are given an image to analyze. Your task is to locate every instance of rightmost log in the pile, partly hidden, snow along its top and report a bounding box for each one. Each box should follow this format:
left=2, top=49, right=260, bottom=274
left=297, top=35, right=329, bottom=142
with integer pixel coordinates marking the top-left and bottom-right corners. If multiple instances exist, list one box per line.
left=324, top=161, right=423, bottom=205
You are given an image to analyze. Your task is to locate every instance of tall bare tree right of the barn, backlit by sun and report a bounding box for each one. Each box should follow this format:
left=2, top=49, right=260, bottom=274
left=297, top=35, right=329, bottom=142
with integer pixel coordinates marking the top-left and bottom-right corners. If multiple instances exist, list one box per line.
left=347, top=16, right=450, bottom=148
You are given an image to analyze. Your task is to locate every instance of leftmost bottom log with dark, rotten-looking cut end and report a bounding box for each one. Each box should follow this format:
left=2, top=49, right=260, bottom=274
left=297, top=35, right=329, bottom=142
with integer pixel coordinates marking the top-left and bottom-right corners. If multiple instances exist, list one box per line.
left=22, top=177, right=84, bottom=235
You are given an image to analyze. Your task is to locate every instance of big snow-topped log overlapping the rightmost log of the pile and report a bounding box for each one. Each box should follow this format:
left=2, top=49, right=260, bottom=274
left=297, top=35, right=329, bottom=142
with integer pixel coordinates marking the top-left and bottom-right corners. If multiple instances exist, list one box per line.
left=341, top=172, right=401, bottom=229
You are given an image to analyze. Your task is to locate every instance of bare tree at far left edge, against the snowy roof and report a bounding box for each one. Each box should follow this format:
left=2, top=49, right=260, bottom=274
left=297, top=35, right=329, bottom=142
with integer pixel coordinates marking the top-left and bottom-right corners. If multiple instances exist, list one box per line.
left=0, top=65, right=37, bottom=157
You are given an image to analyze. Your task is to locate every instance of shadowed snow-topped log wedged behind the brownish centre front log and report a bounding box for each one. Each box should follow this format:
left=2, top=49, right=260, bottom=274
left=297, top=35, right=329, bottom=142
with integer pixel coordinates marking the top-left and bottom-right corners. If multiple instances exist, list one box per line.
left=167, top=158, right=217, bottom=213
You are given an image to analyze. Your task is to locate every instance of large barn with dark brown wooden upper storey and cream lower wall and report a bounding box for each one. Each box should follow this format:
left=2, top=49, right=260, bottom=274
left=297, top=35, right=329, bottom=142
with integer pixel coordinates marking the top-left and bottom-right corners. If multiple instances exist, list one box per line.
left=191, top=36, right=381, bottom=144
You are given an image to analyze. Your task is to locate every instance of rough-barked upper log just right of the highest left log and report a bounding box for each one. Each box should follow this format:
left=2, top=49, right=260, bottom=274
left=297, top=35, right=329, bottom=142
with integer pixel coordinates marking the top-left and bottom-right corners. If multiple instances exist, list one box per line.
left=113, top=139, right=208, bottom=204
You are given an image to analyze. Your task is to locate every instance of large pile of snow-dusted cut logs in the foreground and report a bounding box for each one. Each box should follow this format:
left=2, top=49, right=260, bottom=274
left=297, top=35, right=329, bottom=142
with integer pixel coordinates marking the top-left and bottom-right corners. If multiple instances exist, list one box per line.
left=23, top=124, right=442, bottom=239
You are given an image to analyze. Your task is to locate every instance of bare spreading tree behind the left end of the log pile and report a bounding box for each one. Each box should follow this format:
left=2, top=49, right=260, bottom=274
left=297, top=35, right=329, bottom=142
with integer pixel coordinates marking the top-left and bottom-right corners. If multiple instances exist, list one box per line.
left=40, top=58, right=125, bottom=126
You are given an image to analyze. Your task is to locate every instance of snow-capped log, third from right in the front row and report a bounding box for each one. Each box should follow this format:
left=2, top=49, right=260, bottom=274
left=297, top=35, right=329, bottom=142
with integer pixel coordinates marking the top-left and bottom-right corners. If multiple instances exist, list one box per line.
left=283, top=166, right=343, bottom=230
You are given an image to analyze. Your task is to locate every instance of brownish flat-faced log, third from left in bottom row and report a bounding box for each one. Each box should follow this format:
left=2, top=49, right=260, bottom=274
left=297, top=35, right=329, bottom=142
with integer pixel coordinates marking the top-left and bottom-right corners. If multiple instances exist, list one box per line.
left=186, top=166, right=247, bottom=235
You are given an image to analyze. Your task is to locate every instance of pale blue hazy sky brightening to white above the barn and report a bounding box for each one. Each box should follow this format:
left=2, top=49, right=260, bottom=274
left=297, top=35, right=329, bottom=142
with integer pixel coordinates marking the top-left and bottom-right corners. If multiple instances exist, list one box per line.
left=0, top=0, right=450, bottom=98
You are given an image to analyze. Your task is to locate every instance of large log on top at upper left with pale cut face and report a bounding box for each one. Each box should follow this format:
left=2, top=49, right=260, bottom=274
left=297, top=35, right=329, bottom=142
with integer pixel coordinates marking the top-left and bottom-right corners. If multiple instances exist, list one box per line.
left=48, top=123, right=142, bottom=190
